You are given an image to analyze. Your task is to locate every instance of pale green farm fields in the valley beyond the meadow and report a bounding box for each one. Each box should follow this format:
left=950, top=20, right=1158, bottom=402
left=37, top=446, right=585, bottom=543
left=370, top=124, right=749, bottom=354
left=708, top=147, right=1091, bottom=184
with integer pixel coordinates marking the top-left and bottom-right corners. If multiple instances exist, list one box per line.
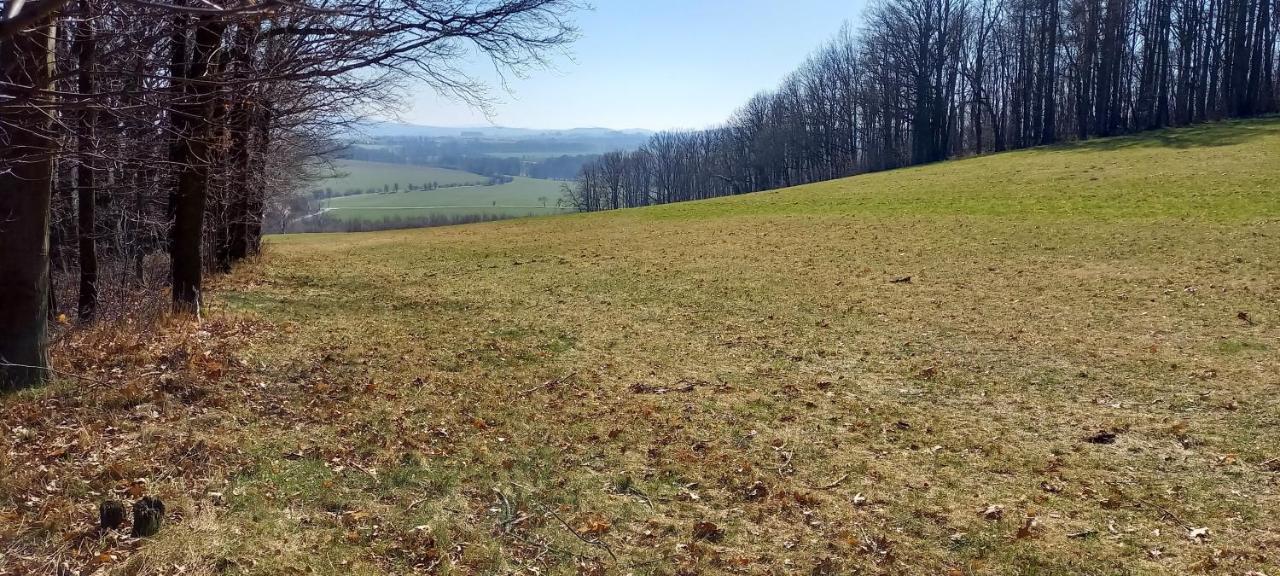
left=325, top=163, right=567, bottom=220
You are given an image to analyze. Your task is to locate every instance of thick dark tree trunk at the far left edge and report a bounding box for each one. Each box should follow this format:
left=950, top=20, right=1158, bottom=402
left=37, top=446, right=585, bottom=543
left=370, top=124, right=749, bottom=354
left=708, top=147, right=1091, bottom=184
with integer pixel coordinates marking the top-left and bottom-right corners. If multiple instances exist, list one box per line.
left=0, top=0, right=56, bottom=390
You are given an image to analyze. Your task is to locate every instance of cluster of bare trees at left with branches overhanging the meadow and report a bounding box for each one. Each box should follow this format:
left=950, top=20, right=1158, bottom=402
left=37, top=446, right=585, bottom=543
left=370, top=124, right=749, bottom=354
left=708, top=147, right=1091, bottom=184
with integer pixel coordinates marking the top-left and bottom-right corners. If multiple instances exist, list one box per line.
left=0, top=0, right=577, bottom=390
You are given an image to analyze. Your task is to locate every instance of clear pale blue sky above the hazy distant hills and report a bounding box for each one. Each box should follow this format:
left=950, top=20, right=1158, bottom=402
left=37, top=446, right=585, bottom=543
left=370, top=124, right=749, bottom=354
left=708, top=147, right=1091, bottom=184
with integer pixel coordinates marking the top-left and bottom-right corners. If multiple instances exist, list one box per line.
left=401, top=0, right=865, bottom=129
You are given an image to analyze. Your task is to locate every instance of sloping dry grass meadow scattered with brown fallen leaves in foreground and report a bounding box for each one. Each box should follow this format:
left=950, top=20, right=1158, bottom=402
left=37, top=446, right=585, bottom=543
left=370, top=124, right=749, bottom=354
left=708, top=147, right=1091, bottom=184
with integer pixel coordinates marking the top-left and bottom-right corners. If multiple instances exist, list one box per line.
left=0, top=120, right=1280, bottom=576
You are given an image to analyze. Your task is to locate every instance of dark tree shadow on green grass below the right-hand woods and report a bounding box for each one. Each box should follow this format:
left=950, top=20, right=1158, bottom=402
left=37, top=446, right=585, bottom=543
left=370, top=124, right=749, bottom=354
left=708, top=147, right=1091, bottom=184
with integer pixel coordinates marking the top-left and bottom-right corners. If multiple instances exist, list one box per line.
left=1062, top=115, right=1280, bottom=152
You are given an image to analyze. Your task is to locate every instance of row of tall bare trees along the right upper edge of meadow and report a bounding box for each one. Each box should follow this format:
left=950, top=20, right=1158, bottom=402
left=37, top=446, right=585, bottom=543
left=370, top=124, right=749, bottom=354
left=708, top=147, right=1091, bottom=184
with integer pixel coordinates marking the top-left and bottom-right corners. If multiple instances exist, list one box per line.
left=566, top=0, right=1280, bottom=210
